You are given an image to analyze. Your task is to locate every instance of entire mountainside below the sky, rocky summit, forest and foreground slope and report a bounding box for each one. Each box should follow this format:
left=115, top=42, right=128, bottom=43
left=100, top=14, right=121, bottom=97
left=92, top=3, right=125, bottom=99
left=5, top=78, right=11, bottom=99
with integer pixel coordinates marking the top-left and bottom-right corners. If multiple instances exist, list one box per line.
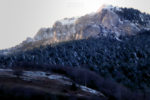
left=0, top=5, right=150, bottom=100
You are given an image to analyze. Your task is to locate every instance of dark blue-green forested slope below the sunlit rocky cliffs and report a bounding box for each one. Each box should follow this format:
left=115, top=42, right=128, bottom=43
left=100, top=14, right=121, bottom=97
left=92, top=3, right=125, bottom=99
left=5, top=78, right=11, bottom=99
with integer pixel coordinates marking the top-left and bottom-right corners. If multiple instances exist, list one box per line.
left=0, top=31, right=150, bottom=89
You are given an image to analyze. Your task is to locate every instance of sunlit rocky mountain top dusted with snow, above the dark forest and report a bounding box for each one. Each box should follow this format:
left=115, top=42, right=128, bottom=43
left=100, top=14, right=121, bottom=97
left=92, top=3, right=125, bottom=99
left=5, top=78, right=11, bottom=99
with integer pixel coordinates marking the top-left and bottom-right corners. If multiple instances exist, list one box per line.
left=0, top=5, right=150, bottom=54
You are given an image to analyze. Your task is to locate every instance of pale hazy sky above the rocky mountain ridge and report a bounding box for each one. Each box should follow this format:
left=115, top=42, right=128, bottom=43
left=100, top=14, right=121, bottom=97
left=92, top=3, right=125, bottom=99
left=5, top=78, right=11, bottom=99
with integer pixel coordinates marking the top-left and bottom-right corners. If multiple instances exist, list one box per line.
left=0, top=0, right=150, bottom=49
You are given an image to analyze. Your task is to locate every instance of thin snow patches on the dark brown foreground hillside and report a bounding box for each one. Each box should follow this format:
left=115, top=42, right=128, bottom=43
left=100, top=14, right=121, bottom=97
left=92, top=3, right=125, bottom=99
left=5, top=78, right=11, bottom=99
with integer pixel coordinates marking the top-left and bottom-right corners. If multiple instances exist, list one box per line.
left=0, top=69, right=104, bottom=96
